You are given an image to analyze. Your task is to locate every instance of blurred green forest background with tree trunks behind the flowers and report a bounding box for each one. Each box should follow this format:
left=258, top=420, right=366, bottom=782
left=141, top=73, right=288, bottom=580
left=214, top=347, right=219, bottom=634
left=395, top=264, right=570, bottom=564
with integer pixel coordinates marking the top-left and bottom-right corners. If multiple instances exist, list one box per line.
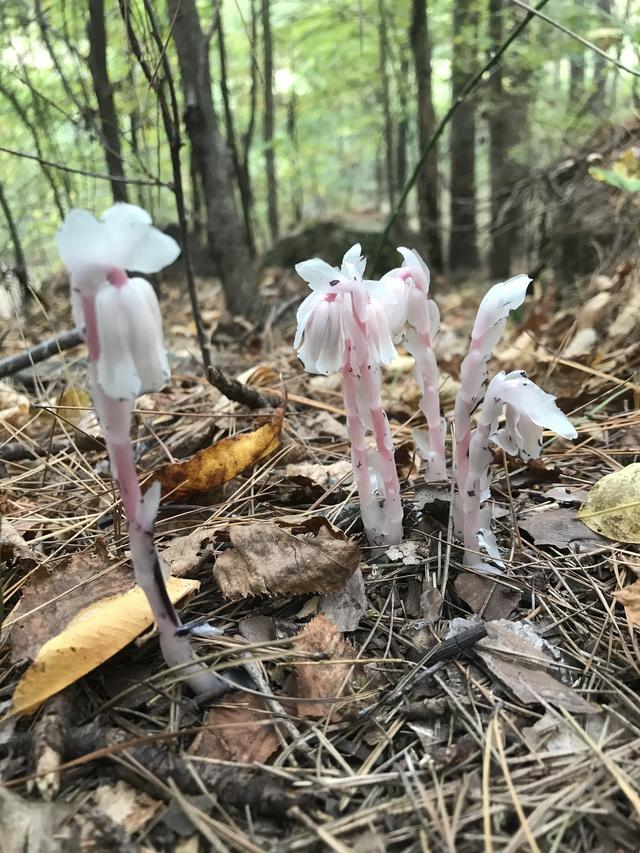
left=0, top=0, right=640, bottom=315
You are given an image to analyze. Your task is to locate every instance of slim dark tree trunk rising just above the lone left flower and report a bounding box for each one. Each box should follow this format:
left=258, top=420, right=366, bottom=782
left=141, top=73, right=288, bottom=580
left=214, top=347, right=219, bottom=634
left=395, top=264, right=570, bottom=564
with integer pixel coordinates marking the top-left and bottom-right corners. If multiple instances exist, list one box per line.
left=87, top=0, right=127, bottom=201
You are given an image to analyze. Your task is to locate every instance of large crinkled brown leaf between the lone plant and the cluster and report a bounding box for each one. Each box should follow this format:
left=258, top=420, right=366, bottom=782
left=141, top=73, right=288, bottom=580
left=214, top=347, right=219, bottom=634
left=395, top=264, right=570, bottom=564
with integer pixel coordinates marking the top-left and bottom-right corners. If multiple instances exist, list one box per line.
left=213, top=516, right=360, bottom=598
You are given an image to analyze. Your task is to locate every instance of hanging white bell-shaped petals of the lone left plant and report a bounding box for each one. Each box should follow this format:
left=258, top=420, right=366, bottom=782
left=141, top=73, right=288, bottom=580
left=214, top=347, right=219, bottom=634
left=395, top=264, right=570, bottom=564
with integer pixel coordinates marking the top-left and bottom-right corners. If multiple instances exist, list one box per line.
left=96, top=278, right=171, bottom=400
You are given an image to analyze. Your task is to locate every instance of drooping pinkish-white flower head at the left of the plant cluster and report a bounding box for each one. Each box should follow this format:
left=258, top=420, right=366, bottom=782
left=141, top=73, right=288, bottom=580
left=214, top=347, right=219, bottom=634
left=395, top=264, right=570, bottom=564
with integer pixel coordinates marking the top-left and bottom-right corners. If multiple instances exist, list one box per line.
left=294, top=243, right=396, bottom=375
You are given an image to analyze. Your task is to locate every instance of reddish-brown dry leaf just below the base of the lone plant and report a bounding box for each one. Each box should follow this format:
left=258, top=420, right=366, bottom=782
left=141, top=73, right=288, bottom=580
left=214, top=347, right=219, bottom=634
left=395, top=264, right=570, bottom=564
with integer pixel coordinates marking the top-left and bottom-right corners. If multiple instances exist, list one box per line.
left=189, top=691, right=280, bottom=764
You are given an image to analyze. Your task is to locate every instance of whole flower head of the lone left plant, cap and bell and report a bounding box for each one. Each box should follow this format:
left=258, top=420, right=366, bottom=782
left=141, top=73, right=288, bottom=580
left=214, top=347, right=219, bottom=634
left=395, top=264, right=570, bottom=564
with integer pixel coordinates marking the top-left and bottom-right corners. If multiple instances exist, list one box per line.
left=57, top=203, right=180, bottom=400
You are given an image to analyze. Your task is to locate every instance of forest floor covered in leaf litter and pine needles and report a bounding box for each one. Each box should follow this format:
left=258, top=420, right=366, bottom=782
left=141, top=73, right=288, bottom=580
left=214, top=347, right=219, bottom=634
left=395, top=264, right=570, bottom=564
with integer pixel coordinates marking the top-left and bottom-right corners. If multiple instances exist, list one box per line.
left=0, top=264, right=640, bottom=853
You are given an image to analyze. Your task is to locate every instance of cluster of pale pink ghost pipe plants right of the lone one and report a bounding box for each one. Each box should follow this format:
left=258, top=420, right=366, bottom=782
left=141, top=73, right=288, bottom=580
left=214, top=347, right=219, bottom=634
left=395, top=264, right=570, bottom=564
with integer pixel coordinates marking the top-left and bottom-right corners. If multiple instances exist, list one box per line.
left=294, top=245, right=576, bottom=572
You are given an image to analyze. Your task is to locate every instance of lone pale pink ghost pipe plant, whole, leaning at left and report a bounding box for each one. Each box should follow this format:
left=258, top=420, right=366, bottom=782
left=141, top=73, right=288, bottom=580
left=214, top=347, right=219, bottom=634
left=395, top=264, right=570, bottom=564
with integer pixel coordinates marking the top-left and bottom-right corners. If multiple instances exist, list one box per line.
left=58, top=203, right=224, bottom=693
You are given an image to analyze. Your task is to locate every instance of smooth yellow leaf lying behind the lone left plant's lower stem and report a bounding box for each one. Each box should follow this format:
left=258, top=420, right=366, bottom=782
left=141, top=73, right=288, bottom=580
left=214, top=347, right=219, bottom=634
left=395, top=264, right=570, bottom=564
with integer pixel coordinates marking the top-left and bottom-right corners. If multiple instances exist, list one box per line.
left=5, top=578, right=200, bottom=719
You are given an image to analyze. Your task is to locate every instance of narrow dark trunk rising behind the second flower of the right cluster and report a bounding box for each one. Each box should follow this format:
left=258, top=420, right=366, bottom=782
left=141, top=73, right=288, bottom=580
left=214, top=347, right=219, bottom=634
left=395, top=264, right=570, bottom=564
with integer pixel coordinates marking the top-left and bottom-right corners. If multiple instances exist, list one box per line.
left=409, top=0, right=442, bottom=270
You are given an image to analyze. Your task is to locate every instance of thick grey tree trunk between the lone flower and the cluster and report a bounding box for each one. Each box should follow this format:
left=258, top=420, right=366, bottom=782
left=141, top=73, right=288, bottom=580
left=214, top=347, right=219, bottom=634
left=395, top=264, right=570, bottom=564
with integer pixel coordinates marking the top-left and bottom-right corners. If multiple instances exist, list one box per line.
left=168, top=0, right=257, bottom=316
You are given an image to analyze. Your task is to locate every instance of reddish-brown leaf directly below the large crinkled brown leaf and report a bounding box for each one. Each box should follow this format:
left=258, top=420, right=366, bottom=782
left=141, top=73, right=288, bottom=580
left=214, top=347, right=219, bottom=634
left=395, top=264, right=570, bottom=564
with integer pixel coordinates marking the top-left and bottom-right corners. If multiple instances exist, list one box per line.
left=295, top=613, right=361, bottom=717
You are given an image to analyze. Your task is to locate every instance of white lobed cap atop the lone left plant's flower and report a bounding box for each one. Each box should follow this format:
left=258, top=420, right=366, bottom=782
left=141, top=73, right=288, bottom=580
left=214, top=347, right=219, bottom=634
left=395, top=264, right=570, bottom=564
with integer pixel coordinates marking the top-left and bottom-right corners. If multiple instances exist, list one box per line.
left=57, top=202, right=180, bottom=286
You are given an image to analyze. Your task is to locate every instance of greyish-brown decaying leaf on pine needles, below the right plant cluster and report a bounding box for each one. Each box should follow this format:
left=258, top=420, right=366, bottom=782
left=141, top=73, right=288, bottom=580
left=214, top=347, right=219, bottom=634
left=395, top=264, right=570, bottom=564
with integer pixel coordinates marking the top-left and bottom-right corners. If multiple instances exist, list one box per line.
left=451, top=619, right=600, bottom=714
